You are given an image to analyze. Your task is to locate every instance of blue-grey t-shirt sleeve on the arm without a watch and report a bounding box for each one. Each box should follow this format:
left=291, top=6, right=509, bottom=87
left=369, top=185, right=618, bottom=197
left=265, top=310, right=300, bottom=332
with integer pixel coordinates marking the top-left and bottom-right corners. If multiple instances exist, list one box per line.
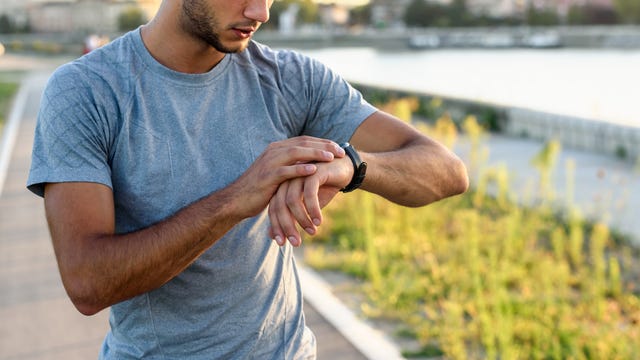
left=27, top=65, right=111, bottom=200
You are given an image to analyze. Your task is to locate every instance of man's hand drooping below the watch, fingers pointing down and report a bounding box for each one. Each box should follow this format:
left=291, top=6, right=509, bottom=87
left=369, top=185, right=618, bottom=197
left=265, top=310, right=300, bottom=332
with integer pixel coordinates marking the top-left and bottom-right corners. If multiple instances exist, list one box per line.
left=269, top=157, right=353, bottom=246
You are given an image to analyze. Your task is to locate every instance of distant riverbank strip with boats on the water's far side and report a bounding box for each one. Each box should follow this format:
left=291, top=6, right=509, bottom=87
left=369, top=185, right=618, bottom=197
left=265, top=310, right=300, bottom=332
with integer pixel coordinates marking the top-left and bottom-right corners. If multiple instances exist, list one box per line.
left=255, top=26, right=640, bottom=51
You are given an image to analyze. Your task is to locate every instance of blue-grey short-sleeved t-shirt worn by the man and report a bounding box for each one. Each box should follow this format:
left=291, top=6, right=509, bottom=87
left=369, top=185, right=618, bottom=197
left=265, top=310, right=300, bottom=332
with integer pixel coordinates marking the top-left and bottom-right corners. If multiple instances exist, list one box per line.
left=27, top=30, right=375, bottom=360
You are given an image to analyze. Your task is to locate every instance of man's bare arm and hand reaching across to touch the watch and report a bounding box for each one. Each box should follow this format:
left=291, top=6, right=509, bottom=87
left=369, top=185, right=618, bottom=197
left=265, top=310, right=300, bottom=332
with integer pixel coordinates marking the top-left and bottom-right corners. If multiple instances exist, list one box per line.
left=45, top=137, right=344, bottom=315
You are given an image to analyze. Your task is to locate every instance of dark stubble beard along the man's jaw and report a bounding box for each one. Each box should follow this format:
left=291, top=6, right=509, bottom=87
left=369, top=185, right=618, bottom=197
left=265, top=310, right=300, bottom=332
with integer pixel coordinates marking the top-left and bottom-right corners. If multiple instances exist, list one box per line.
left=180, top=0, right=247, bottom=54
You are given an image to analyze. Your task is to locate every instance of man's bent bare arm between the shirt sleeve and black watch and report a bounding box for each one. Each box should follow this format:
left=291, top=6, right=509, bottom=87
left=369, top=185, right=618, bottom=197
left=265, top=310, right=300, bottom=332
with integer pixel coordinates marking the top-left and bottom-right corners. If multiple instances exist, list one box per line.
left=351, top=112, right=469, bottom=207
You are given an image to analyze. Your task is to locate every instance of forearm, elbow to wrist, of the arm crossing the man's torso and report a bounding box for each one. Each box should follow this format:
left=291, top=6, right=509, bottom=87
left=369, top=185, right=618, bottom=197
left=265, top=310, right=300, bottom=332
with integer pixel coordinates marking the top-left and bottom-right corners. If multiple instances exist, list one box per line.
left=56, top=187, right=241, bottom=315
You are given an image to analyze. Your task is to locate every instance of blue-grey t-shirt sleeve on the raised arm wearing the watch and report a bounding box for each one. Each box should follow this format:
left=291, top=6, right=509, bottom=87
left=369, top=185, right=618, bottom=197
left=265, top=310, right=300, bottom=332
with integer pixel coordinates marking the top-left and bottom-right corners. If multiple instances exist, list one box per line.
left=283, top=52, right=377, bottom=143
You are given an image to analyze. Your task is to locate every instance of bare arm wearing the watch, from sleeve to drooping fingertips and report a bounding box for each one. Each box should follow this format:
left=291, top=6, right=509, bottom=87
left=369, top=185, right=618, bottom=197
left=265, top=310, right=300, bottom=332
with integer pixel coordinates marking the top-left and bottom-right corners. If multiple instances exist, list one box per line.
left=269, top=111, right=469, bottom=245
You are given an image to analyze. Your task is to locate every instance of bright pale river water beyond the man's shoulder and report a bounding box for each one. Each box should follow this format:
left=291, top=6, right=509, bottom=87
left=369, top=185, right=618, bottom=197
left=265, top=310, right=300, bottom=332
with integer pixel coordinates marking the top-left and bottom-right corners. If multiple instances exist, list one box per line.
left=288, top=47, right=640, bottom=163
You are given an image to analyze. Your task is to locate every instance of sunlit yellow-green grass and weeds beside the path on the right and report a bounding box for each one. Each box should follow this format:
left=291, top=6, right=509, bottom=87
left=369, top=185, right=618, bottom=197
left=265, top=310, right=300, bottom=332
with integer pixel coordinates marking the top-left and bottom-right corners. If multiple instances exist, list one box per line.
left=305, top=99, right=640, bottom=359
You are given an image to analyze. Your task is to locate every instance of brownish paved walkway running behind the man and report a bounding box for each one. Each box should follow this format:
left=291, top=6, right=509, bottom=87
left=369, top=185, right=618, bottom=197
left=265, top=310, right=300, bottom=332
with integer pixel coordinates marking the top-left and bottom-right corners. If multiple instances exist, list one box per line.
left=0, top=65, right=376, bottom=360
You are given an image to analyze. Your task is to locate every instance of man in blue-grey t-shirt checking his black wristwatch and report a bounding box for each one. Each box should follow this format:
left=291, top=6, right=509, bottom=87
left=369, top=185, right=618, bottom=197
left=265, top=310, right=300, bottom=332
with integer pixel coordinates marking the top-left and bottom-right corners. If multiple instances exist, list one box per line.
left=27, top=0, right=467, bottom=359
